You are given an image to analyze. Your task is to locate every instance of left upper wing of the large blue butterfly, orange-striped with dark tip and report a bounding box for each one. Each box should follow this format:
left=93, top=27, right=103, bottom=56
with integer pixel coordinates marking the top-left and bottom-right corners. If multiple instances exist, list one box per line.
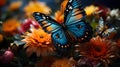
left=33, top=12, right=61, bottom=33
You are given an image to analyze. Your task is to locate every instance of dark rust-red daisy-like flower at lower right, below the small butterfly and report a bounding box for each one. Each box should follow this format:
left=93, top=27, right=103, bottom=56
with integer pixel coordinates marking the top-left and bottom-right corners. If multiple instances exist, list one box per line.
left=81, top=36, right=117, bottom=63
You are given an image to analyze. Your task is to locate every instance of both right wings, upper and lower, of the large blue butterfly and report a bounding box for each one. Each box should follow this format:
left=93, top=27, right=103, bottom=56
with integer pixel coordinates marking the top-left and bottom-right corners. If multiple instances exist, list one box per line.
left=64, top=0, right=92, bottom=42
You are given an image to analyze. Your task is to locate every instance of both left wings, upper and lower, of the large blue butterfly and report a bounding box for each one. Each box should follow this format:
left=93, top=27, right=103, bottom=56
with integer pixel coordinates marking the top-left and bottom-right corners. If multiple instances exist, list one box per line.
left=33, top=12, right=69, bottom=51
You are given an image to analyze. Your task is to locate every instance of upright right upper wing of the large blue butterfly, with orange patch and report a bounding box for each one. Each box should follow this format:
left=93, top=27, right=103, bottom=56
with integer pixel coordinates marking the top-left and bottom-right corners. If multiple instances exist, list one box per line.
left=64, top=0, right=85, bottom=25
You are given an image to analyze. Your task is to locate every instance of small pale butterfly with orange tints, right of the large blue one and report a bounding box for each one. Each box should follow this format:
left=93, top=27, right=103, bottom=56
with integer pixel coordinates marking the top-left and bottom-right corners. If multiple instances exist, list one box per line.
left=96, top=17, right=116, bottom=37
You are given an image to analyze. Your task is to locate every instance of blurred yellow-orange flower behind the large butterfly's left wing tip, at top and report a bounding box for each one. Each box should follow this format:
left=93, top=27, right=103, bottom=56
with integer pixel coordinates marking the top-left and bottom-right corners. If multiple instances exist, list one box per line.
left=24, top=1, right=51, bottom=17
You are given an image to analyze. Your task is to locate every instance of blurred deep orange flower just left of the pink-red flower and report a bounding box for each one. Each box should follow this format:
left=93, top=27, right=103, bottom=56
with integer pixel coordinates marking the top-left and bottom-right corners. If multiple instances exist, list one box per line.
left=2, top=18, right=20, bottom=35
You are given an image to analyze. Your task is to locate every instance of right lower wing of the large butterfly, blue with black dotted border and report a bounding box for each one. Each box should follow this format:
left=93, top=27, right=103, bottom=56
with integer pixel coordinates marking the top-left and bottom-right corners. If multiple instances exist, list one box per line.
left=67, top=21, right=93, bottom=42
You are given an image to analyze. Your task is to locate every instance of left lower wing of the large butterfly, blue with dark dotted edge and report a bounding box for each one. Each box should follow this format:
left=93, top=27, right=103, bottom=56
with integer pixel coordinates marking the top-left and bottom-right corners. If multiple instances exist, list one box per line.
left=52, top=29, right=69, bottom=52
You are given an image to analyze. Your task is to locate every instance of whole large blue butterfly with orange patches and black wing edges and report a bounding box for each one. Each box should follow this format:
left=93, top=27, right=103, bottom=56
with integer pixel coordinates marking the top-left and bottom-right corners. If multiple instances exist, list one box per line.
left=33, top=0, right=92, bottom=52
